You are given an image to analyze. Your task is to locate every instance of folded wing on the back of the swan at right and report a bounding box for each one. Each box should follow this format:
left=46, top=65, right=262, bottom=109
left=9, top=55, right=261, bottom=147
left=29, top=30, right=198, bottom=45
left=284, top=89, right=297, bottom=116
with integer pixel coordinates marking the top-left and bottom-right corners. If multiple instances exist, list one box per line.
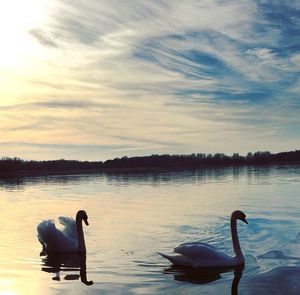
left=174, top=242, right=221, bottom=259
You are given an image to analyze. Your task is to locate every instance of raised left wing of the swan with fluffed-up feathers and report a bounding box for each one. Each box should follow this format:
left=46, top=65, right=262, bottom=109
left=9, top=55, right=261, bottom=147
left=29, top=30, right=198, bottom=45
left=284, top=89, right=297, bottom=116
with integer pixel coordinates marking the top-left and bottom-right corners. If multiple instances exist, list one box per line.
left=37, top=220, right=77, bottom=252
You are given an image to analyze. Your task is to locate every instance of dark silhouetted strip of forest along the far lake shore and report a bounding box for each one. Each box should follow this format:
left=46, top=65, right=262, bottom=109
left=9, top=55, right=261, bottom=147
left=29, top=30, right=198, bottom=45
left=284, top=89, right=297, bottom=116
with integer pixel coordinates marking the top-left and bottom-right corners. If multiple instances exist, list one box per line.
left=0, top=150, right=300, bottom=176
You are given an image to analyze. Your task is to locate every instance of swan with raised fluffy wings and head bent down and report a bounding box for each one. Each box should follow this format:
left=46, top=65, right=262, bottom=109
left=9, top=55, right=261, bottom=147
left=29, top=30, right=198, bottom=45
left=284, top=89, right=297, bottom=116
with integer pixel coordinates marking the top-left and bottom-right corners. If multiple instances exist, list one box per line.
left=37, top=210, right=89, bottom=253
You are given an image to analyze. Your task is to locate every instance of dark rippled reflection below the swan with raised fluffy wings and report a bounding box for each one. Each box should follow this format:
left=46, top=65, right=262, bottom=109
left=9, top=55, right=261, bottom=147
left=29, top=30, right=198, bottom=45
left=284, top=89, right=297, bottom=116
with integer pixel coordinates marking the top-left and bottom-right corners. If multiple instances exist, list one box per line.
left=42, top=252, right=93, bottom=286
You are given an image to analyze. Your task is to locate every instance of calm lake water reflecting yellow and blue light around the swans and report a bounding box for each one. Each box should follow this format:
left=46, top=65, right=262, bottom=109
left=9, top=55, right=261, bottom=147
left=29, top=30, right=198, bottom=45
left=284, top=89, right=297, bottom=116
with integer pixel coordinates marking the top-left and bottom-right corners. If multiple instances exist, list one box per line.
left=0, top=166, right=300, bottom=295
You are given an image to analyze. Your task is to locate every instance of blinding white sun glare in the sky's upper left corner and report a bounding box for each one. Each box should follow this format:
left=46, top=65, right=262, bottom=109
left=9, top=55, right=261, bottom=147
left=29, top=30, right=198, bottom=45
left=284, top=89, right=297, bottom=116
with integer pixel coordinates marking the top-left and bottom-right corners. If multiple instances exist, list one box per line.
left=0, top=0, right=56, bottom=105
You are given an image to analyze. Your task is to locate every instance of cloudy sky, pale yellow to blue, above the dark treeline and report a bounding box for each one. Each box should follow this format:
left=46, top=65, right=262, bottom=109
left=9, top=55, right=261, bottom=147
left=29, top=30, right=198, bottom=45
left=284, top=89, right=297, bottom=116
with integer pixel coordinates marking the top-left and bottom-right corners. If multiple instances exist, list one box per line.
left=0, top=0, right=300, bottom=160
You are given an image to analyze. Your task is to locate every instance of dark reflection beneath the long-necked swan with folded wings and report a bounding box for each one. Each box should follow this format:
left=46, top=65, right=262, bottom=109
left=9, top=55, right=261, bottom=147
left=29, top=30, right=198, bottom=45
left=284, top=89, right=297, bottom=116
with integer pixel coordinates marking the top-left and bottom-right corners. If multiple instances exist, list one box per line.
left=164, top=265, right=244, bottom=295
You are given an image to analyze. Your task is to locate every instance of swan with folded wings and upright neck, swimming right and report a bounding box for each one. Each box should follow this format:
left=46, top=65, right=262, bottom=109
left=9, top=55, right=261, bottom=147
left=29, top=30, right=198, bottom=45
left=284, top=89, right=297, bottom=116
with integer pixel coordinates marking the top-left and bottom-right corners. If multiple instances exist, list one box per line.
left=158, top=210, right=248, bottom=268
